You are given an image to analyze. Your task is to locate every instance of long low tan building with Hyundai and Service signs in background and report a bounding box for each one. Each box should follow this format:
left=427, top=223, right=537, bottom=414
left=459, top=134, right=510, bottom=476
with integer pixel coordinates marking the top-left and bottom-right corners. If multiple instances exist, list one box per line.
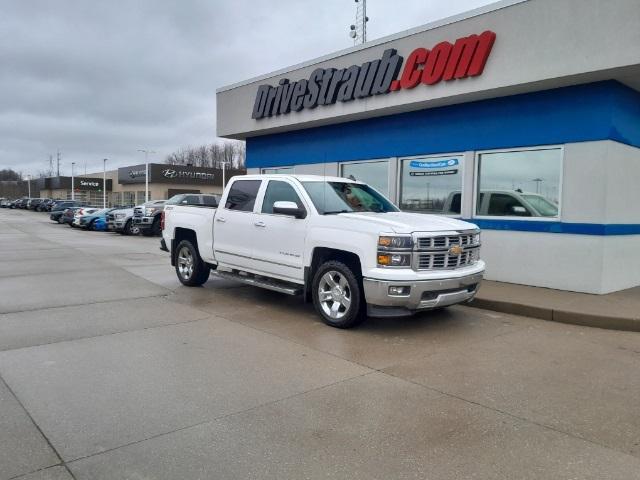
left=37, top=163, right=245, bottom=206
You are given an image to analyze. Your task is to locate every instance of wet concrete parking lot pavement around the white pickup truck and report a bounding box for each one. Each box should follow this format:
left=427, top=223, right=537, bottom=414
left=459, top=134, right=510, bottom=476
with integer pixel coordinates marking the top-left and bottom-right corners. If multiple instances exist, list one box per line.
left=0, top=209, right=640, bottom=480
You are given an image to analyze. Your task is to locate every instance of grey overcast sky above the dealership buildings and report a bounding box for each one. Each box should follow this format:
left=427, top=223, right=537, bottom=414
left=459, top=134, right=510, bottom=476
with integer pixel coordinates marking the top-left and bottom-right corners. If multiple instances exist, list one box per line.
left=0, top=0, right=492, bottom=174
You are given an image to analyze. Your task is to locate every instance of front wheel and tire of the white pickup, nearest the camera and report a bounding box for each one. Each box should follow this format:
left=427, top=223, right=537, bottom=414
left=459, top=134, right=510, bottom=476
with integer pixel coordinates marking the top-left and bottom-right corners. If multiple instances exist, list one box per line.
left=311, top=260, right=366, bottom=328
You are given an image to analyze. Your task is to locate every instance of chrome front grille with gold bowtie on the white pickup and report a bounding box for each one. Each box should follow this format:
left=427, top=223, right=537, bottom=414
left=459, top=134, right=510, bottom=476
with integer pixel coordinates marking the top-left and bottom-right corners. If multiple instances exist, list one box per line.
left=413, top=232, right=480, bottom=270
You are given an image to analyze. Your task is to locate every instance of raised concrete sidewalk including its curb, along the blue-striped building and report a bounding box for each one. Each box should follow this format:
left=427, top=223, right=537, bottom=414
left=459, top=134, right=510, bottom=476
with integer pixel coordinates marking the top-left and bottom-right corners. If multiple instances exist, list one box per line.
left=469, top=280, right=640, bottom=332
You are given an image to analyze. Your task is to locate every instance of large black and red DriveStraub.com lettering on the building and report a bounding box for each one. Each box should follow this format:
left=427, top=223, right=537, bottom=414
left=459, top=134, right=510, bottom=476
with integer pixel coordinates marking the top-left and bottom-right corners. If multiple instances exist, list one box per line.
left=251, top=30, right=496, bottom=120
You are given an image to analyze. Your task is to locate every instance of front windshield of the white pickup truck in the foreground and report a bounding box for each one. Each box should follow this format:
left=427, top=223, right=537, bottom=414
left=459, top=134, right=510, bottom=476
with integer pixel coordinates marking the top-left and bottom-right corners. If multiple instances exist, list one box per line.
left=302, top=182, right=398, bottom=215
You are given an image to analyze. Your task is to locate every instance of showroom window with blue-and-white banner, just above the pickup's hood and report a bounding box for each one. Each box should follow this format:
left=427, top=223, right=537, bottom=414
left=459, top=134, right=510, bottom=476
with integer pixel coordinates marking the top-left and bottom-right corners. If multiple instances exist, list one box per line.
left=400, top=155, right=463, bottom=215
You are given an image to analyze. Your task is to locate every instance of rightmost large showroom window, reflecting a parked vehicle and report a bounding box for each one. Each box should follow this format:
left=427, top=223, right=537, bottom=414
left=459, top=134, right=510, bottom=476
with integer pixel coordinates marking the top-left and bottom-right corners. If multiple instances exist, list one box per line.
left=476, top=148, right=562, bottom=218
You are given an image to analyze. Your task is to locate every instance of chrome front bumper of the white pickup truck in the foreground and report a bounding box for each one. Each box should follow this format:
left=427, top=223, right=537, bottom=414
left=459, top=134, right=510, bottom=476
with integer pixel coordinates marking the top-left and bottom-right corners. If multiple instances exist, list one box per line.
left=363, top=271, right=484, bottom=317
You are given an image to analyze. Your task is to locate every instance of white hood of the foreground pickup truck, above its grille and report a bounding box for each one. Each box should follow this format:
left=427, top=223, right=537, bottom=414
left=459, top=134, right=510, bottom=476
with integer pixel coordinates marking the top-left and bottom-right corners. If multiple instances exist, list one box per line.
left=337, top=212, right=478, bottom=233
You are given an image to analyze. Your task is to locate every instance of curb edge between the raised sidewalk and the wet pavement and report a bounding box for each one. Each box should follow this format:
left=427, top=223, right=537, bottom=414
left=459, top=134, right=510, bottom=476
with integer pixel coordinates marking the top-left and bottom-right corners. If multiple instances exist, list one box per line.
left=467, top=297, right=640, bottom=332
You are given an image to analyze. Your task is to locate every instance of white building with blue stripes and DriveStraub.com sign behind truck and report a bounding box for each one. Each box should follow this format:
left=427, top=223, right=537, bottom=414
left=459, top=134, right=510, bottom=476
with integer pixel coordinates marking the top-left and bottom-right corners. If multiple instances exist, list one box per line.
left=217, top=0, right=640, bottom=294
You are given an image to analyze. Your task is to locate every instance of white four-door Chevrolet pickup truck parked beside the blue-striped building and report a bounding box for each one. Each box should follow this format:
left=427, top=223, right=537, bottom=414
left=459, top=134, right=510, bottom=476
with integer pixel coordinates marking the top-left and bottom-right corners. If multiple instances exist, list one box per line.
left=161, top=175, right=485, bottom=328
